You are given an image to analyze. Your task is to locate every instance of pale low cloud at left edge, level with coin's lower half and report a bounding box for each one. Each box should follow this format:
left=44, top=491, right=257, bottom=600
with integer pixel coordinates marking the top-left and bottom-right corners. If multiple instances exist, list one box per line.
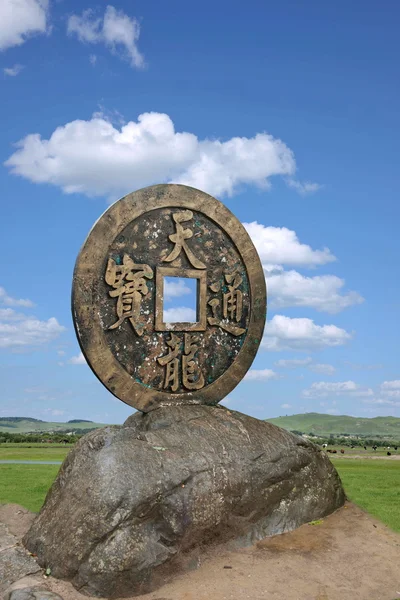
left=0, top=309, right=65, bottom=349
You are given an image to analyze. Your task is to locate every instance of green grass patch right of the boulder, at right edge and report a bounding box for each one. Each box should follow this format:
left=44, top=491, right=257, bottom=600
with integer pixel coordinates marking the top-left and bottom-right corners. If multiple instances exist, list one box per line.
left=333, top=459, right=400, bottom=531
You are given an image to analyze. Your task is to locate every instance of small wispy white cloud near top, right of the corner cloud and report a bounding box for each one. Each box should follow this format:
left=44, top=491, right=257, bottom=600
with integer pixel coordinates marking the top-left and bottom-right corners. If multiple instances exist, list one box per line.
left=67, top=6, right=144, bottom=68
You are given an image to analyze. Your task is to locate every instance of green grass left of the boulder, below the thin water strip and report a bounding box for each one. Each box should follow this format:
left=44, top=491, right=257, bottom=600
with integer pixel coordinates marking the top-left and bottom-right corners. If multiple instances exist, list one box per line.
left=0, top=465, right=60, bottom=512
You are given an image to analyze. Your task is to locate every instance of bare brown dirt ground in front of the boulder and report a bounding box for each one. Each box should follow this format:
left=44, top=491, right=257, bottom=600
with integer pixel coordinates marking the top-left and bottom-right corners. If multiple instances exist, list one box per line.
left=0, top=503, right=400, bottom=600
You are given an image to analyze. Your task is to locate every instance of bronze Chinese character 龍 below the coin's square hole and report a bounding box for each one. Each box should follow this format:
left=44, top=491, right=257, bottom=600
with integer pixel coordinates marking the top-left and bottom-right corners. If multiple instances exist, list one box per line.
left=157, top=333, right=204, bottom=392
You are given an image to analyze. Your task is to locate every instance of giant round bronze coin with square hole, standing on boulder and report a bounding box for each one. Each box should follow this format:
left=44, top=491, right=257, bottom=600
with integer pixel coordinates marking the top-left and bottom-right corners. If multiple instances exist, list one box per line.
left=72, top=184, right=266, bottom=412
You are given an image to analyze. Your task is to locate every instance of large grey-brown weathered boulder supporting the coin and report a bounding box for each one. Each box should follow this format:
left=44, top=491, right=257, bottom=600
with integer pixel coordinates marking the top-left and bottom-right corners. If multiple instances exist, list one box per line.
left=24, top=406, right=344, bottom=598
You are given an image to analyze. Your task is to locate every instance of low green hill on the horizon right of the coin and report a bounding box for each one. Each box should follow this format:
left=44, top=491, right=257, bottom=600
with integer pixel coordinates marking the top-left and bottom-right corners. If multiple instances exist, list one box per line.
left=266, top=413, right=400, bottom=440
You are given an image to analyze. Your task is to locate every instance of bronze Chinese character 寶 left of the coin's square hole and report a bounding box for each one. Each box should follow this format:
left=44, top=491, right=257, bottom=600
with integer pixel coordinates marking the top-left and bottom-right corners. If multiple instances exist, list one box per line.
left=105, top=254, right=153, bottom=336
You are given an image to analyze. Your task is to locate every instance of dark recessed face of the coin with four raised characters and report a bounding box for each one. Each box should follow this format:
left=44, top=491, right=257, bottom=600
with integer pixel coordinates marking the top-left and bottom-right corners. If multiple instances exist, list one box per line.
left=104, top=209, right=250, bottom=393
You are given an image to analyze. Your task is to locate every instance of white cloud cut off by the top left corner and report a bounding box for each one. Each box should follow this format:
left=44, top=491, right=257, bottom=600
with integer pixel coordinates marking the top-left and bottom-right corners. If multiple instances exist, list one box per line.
left=0, top=0, right=49, bottom=50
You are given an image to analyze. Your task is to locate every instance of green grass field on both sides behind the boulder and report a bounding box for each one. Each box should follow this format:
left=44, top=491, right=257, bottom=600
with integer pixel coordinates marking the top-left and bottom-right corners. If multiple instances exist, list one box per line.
left=0, top=444, right=400, bottom=532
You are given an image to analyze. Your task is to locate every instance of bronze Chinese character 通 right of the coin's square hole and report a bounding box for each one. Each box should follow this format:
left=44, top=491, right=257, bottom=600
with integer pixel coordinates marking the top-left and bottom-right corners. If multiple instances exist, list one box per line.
left=207, top=273, right=246, bottom=336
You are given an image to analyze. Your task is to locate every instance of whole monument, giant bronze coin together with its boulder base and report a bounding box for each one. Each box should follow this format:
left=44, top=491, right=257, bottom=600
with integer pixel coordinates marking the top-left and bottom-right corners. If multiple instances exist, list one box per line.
left=24, top=184, right=344, bottom=598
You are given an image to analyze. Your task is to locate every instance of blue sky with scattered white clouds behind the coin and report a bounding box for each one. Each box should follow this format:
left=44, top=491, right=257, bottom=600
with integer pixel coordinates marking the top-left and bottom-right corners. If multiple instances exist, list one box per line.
left=0, top=0, right=400, bottom=423
